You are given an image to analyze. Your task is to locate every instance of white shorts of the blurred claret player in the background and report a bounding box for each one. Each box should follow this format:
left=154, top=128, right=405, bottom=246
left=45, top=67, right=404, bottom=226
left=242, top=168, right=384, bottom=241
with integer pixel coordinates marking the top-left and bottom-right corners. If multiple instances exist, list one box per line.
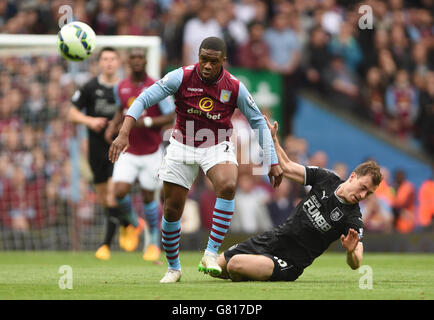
left=113, top=147, right=163, bottom=191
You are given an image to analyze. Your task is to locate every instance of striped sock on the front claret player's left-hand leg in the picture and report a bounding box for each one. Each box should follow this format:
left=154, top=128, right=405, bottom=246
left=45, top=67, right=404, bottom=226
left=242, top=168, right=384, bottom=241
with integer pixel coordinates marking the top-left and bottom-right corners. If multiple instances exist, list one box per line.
left=161, top=217, right=181, bottom=270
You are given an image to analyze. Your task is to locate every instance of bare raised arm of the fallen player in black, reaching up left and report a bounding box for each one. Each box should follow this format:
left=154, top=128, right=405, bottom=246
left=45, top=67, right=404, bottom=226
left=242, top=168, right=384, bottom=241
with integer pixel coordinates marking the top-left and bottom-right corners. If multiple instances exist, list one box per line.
left=264, top=116, right=306, bottom=185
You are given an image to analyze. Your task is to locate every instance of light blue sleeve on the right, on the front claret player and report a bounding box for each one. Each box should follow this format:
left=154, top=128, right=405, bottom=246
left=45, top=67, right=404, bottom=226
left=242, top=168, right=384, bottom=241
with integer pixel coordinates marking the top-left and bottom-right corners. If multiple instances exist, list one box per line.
left=237, top=82, right=279, bottom=165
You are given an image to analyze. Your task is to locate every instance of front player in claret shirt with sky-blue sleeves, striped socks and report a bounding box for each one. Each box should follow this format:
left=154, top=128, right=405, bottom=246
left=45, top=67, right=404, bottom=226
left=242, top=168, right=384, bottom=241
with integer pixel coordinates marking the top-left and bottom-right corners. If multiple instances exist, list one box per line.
left=109, top=37, right=282, bottom=283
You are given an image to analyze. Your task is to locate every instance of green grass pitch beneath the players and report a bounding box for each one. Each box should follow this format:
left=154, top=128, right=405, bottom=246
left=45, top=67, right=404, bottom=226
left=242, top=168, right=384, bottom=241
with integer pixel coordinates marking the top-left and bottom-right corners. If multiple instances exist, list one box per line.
left=0, top=251, right=434, bottom=300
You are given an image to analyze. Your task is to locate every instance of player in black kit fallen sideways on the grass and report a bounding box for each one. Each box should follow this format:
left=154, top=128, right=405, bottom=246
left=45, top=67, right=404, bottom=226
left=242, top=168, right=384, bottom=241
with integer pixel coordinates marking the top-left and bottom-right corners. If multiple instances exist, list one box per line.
left=217, top=119, right=382, bottom=281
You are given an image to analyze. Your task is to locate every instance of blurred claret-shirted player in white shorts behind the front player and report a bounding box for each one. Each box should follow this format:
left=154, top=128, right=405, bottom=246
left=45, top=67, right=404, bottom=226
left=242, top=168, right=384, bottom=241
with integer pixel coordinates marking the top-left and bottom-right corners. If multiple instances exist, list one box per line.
left=105, top=48, right=175, bottom=261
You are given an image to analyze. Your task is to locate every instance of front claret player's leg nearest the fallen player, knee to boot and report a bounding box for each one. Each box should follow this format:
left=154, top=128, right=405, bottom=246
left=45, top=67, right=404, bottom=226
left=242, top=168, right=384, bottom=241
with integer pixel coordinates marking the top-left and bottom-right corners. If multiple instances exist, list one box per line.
left=199, top=162, right=238, bottom=276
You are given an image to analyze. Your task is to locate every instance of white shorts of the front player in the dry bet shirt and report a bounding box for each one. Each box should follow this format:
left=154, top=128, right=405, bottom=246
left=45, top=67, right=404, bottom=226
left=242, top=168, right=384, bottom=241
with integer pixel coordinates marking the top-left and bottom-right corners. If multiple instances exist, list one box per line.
left=159, top=137, right=238, bottom=189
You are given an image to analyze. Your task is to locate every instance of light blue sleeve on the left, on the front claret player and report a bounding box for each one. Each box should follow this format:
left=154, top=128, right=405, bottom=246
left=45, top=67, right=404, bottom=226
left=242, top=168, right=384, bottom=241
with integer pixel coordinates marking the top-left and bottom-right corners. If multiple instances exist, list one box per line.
left=126, top=68, right=184, bottom=120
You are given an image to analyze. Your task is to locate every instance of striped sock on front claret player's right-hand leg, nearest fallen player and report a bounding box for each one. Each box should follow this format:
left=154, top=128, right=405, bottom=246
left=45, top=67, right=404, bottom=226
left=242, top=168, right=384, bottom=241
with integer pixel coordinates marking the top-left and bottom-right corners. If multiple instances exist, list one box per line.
left=205, top=198, right=235, bottom=254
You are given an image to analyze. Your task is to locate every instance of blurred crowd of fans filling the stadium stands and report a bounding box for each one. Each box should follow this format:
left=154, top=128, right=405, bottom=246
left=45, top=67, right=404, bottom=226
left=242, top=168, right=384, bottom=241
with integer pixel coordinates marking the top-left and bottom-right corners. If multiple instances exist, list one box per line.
left=0, top=0, right=434, bottom=250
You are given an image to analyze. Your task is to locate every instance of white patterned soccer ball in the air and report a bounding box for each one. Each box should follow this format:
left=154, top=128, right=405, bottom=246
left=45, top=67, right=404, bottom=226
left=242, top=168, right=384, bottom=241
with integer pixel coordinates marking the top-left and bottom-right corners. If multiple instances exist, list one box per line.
left=57, top=21, right=96, bottom=61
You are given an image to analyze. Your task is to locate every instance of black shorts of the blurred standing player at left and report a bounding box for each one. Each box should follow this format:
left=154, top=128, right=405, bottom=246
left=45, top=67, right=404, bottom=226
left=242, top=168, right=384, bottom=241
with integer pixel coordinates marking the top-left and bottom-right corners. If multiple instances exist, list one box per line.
left=89, top=144, right=113, bottom=184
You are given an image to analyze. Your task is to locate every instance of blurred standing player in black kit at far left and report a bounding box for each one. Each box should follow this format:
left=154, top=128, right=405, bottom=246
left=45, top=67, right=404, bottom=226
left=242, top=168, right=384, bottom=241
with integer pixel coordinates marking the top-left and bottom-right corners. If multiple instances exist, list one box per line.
left=68, top=47, right=143, bottom=260
